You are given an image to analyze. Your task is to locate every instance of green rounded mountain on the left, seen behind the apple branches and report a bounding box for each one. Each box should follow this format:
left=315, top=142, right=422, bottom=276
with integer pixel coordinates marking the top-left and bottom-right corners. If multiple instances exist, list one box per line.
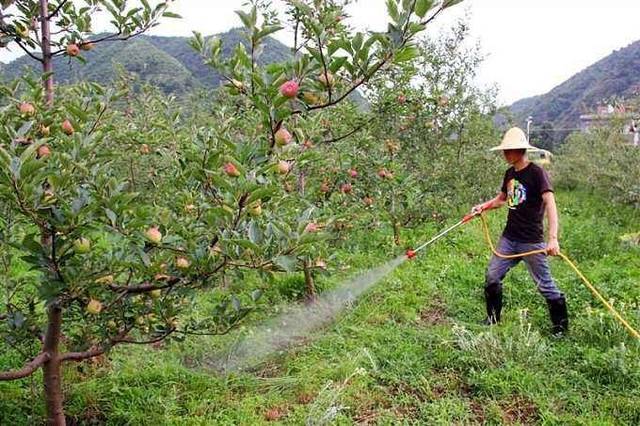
left=0, top=29, right=291, bottom=94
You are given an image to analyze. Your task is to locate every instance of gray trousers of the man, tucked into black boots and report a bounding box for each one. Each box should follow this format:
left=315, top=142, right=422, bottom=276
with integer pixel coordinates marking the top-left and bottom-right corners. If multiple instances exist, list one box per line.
left=485, top=237, right=564, bottom=300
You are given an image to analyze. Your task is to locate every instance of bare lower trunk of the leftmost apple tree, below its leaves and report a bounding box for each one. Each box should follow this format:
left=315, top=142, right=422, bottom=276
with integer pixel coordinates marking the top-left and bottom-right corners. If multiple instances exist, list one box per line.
left=43, top=302, right=66, bottom=426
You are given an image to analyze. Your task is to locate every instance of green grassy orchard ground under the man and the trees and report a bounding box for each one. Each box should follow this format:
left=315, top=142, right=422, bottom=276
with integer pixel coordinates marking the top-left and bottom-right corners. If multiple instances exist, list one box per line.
left=0, top=193, right=640, bottom=425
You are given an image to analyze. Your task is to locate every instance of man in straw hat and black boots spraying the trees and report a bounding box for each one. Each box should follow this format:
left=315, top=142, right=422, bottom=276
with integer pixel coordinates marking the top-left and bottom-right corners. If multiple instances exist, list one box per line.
left=472, top=127, right=569, bottom=334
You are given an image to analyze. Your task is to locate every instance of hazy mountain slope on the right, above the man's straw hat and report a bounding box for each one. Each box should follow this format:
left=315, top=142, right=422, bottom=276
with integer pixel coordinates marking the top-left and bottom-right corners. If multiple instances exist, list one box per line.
left=511, top=41, right=640, bottom=128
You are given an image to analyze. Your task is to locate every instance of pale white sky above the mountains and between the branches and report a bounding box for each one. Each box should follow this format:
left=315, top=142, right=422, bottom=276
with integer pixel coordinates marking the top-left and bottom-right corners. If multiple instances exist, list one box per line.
left=0, top=0, right=640, bottom=103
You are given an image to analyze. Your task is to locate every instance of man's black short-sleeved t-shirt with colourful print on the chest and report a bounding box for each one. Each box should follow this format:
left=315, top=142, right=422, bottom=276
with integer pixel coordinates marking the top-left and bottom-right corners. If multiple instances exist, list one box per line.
left=502, top=163, right=553, bottom=243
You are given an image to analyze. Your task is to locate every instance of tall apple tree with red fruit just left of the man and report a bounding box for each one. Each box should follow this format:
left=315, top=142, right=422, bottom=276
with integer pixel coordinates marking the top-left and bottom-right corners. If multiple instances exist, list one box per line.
left=361, top=20, right=496, bottom=245
